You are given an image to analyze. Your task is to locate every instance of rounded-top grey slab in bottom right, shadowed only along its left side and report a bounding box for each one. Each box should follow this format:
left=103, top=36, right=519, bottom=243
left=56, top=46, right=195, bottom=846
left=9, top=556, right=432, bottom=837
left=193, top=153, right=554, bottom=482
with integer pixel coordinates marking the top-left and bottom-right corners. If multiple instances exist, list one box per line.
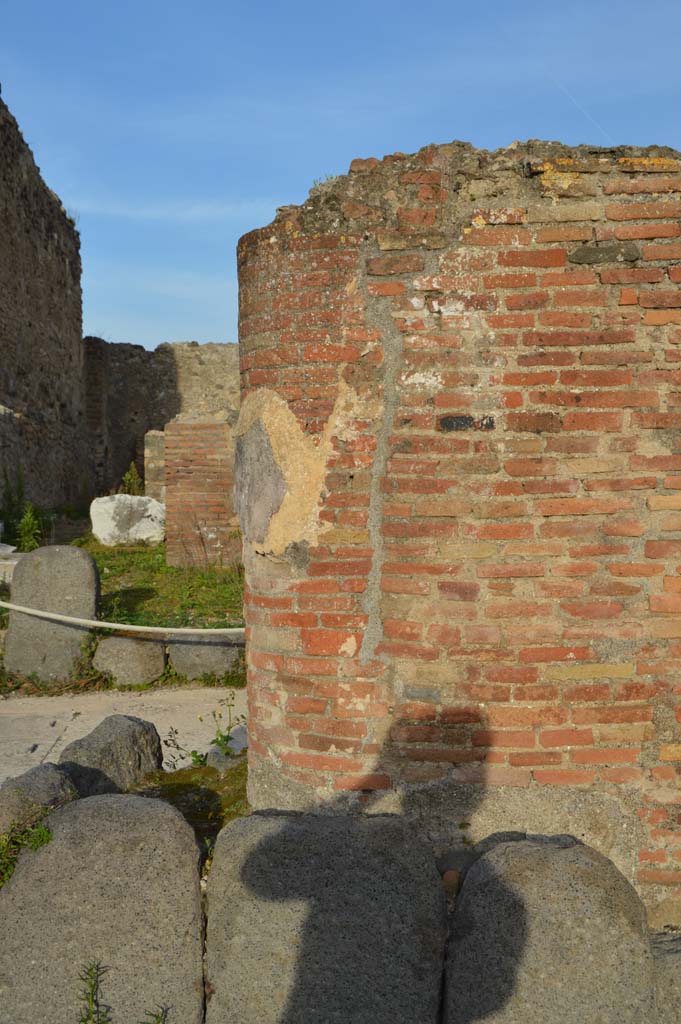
left=444, top=836, right=655, bottom=1024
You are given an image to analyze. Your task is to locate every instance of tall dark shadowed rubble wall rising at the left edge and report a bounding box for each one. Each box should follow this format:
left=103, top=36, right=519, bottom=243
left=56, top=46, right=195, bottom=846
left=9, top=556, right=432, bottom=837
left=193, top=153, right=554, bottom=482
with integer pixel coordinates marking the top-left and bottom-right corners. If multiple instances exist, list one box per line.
left=0, top=100, right=92, bottom=505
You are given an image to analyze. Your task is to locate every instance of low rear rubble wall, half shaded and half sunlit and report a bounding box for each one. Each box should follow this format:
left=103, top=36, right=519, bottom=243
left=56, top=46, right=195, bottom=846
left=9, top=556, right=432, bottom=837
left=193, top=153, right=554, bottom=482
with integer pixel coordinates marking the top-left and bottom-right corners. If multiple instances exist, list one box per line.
left=85, top=338, right=239, bottom=494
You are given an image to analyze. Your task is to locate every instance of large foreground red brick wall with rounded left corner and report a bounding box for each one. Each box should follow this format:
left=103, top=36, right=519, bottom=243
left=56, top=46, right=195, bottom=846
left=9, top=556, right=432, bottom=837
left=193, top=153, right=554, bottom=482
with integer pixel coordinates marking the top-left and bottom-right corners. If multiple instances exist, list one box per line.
left=238, top=143, right=681, bottom=924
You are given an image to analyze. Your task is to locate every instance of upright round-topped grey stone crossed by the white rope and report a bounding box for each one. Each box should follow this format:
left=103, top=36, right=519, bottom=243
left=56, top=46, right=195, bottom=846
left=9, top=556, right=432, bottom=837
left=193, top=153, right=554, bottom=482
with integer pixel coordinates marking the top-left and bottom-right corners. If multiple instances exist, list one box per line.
left=4, top=544, right=99, bottom=682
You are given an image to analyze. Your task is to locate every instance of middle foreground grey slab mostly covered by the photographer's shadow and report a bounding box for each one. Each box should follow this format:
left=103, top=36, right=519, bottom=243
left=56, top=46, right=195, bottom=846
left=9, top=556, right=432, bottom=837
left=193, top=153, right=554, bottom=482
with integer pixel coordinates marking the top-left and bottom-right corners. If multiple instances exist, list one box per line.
left=206, top=814, right=445, bottom=1024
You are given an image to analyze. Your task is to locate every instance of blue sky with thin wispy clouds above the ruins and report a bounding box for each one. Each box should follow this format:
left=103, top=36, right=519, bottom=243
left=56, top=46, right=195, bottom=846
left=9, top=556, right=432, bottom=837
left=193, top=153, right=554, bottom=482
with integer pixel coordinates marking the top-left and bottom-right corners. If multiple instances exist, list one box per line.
left=0, top=0, right=681, bottom=348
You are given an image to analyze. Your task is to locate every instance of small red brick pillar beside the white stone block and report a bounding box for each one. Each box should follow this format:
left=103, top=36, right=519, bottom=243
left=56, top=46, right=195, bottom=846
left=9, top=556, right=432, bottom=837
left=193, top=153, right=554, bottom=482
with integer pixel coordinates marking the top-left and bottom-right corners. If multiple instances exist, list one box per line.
left=165, top=421, right=241, bottom=565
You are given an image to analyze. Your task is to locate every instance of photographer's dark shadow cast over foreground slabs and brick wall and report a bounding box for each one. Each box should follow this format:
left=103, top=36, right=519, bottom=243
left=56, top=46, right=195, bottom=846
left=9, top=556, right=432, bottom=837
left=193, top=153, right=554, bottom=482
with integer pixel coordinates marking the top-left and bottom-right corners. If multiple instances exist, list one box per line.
left=241, top=714, right=525, bottom=1024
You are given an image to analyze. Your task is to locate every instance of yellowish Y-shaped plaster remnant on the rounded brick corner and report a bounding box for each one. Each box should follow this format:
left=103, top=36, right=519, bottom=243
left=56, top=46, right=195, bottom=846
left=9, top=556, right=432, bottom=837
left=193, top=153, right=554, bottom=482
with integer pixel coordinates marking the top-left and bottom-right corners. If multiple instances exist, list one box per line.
left=235, top=377, right=383, bottom=555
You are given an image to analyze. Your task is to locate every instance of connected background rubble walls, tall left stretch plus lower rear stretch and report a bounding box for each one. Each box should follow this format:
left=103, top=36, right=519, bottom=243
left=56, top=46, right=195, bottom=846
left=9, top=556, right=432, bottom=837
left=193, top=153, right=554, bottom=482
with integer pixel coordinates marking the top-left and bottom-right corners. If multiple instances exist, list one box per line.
left=0, top=93, right=239, bottom=524
